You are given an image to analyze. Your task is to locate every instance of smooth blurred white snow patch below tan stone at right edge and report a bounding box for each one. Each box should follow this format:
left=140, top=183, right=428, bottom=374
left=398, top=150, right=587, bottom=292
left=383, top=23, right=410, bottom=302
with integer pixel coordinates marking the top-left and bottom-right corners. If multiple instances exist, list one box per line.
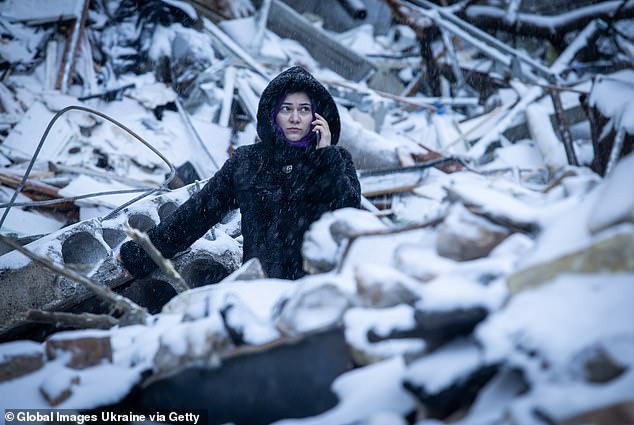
left=476, top=274, right=634, bottom=370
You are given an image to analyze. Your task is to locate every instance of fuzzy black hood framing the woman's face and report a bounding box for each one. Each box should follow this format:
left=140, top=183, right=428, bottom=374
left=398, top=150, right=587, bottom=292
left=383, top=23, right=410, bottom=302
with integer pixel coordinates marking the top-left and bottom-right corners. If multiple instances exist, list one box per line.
left=257, top=66, right=341, bottom=145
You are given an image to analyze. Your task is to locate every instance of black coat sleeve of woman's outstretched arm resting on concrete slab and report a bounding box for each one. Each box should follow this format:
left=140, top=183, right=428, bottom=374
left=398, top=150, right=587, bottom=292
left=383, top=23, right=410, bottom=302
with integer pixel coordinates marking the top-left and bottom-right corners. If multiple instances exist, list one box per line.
left=120, top=154, right=237, bottom=278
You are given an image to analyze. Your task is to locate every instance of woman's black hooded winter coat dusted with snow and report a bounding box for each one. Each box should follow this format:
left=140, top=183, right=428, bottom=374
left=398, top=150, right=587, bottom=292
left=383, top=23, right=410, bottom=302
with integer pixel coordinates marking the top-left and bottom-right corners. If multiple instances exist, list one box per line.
left=120, top=66, right=361, bottom=279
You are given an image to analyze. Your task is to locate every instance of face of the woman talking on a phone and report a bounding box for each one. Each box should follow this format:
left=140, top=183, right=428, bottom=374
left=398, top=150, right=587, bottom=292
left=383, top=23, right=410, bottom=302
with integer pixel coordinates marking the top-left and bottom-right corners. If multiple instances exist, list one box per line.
left=275, top=92, right=313, bottom=142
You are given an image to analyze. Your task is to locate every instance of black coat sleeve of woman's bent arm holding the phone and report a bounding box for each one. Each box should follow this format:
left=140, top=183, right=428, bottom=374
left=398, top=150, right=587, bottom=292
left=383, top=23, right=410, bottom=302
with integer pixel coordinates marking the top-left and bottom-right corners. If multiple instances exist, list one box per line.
left=311, top=146, right=361, bottom=210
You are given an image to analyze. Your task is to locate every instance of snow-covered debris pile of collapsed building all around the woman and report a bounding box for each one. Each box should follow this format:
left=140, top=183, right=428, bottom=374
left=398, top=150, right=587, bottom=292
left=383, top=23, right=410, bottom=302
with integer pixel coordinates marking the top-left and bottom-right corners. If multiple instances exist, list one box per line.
left=0, top=0, right=634, bottom=425
